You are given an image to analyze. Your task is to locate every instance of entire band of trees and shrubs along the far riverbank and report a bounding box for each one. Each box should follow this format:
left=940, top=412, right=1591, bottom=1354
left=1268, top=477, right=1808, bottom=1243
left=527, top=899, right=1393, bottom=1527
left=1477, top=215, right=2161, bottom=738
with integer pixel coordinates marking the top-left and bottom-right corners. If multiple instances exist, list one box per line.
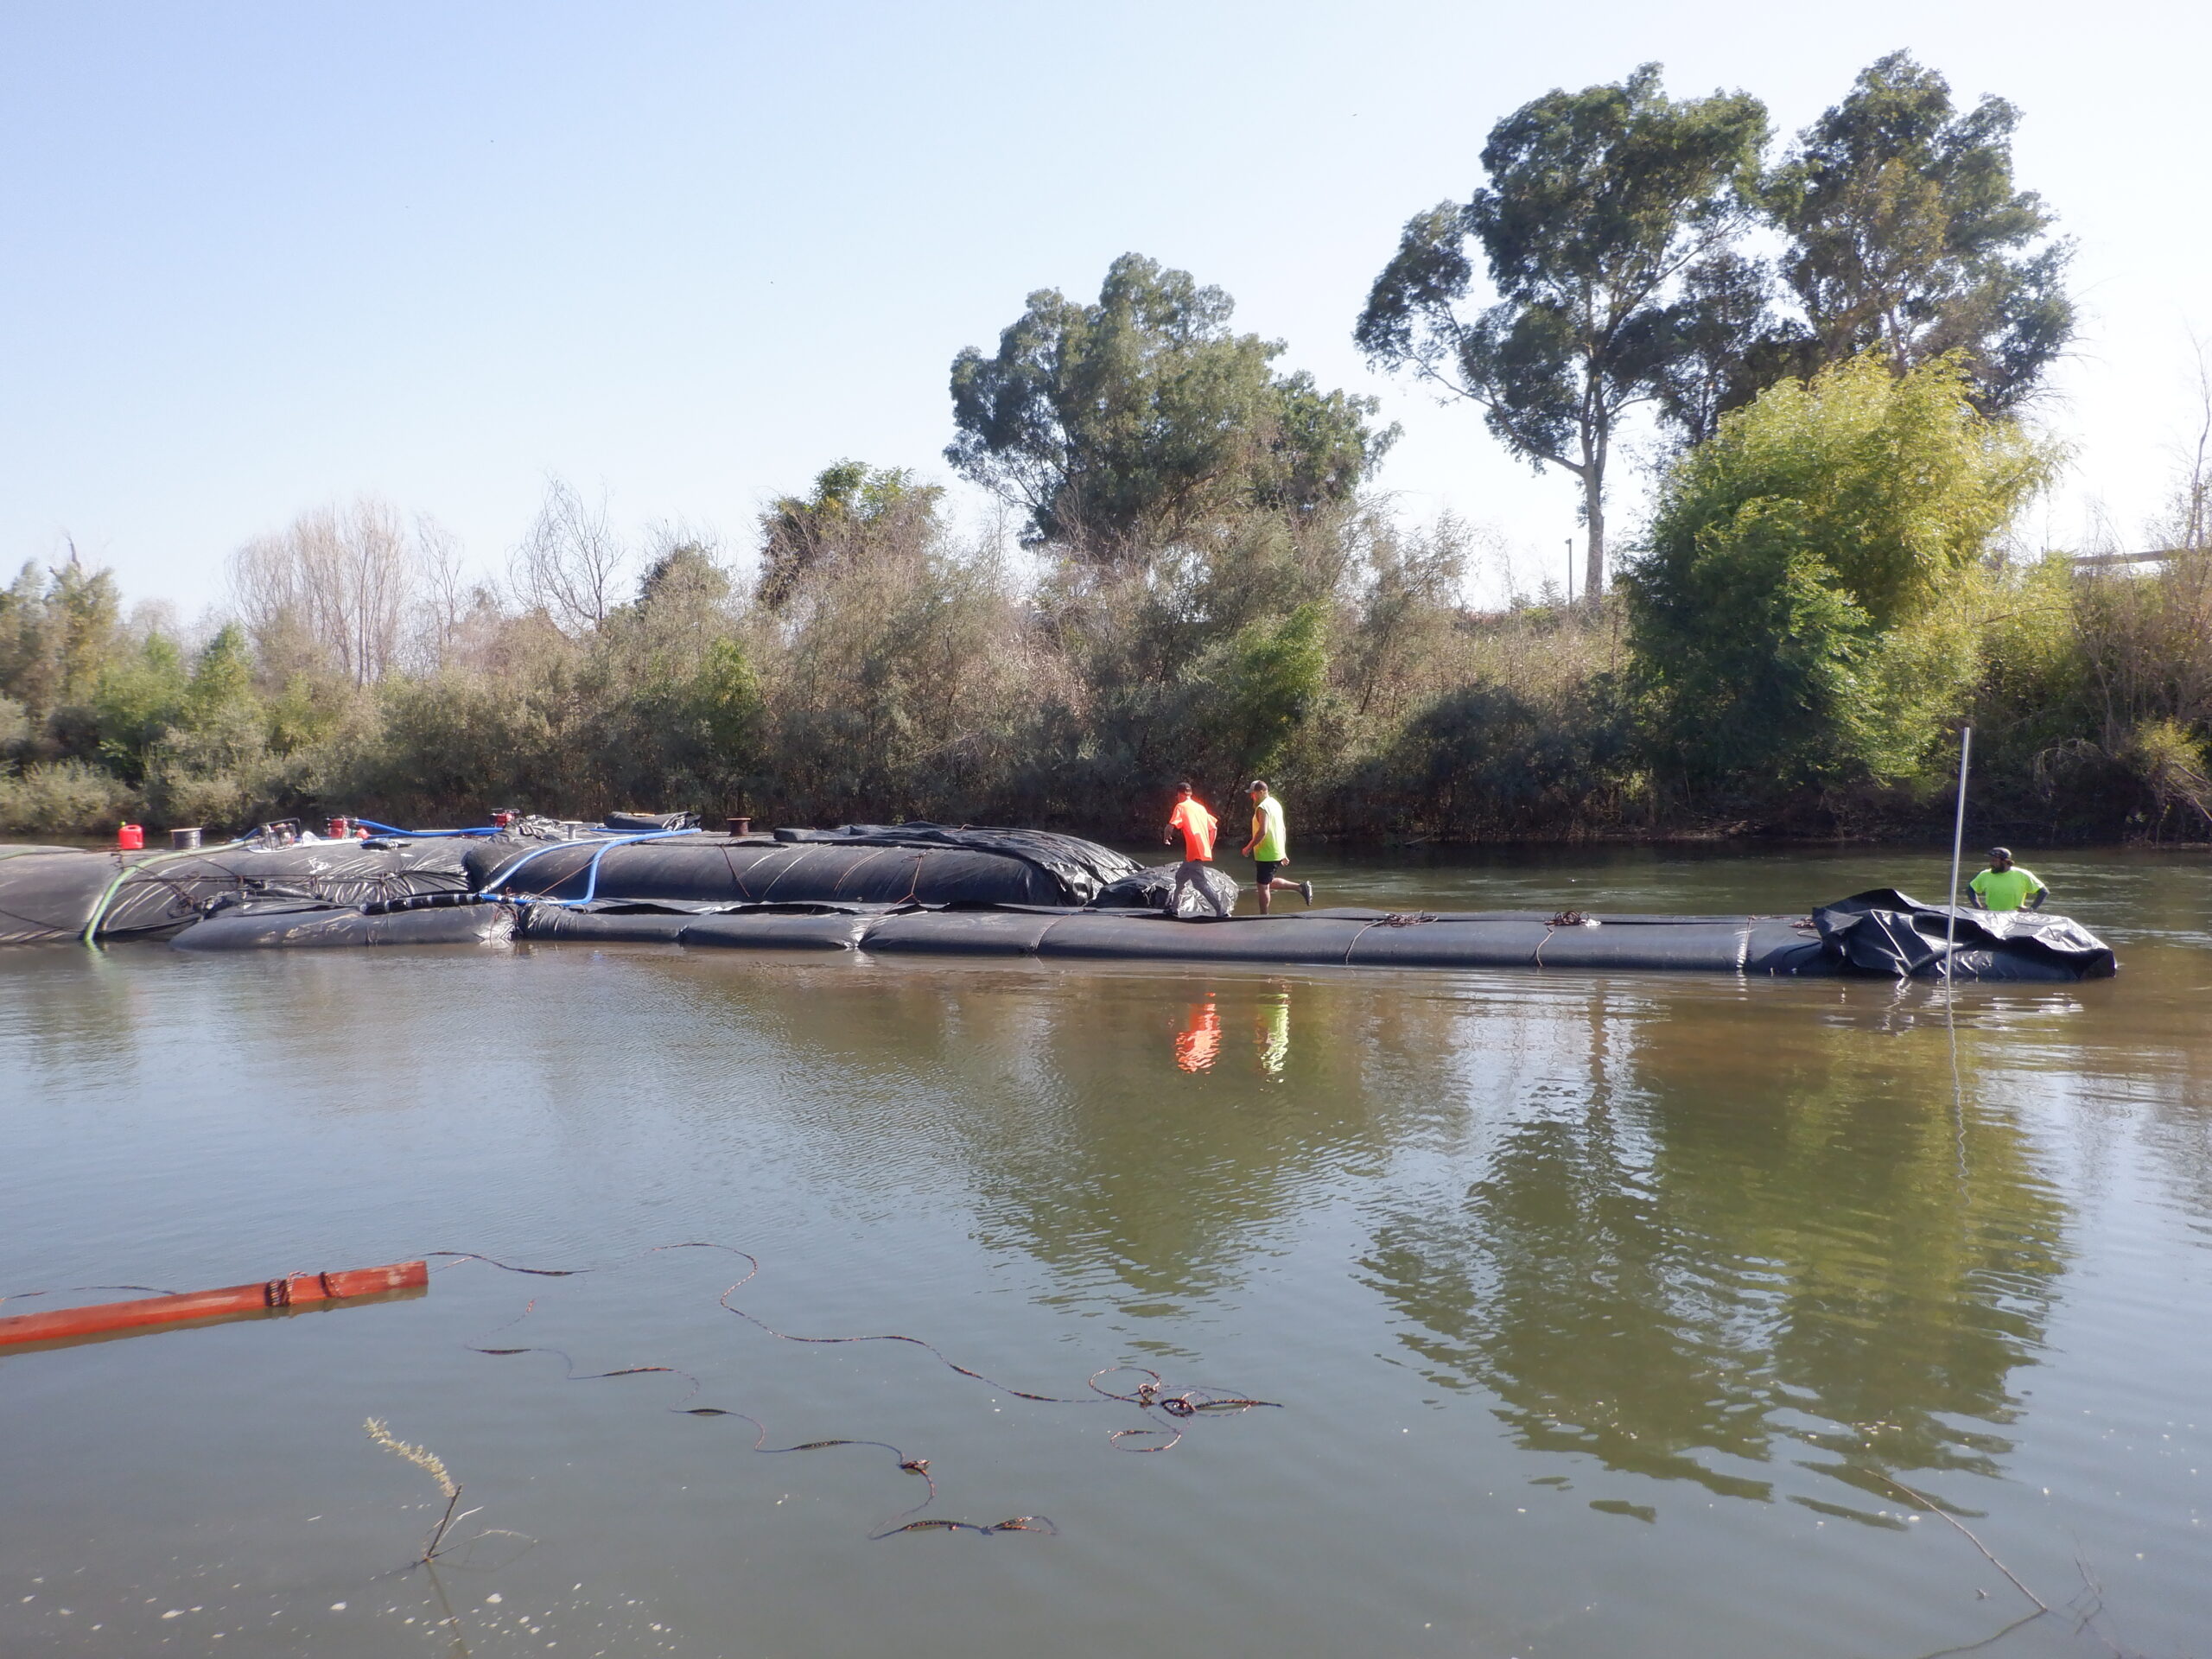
left=0, top=55, right=2212, bottom=838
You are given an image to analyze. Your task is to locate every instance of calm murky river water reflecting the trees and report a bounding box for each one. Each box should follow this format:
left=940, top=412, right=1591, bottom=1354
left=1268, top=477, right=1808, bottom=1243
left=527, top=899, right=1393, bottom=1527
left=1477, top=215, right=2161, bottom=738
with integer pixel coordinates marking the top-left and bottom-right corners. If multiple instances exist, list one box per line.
left=0, top=849, right=2212, bottom=1659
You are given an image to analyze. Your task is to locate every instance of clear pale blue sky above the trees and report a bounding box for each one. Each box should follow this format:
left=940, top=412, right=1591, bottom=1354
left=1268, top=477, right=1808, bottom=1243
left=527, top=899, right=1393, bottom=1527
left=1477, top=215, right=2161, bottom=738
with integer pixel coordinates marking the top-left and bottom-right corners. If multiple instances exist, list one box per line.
left=0, top=0, right=2212, bottom=613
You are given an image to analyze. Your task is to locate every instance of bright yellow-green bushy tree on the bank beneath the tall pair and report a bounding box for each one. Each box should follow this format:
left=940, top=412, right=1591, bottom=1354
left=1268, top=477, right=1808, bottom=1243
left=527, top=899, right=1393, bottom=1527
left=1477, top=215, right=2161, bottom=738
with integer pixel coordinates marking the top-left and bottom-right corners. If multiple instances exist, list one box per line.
left=1624, top=356, right=2050, bottom=801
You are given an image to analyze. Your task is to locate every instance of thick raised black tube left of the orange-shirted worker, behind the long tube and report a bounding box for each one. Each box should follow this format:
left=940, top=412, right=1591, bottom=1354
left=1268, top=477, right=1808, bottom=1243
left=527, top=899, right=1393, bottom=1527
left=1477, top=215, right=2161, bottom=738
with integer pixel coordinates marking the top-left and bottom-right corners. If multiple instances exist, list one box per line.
left=462, top=836, right=1079, bottom=905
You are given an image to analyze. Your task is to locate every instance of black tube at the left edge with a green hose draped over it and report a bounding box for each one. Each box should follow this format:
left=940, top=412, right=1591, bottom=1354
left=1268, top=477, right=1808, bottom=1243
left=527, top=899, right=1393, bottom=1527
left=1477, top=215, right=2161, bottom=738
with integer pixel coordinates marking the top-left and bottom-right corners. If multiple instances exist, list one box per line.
left=0, top=841, right=469, bottom=944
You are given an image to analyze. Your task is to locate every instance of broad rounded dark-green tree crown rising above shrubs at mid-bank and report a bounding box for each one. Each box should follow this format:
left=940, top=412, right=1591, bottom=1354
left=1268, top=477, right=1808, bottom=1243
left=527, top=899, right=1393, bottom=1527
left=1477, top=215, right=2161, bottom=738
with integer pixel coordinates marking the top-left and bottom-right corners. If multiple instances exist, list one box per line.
left=944, top=254, right=1395, bottom=562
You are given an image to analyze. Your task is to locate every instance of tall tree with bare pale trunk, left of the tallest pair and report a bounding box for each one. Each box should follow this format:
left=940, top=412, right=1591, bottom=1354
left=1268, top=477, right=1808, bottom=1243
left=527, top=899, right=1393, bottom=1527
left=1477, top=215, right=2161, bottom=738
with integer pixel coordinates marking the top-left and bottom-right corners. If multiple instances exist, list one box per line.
left=1354, top=64, right=1767, bottom=601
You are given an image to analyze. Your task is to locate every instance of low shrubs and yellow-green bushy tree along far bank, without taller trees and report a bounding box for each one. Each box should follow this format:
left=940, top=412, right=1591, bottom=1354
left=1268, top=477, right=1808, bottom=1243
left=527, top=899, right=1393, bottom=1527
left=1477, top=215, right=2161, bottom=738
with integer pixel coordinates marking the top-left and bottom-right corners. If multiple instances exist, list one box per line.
left=0, top=363, right=2212, bottom=841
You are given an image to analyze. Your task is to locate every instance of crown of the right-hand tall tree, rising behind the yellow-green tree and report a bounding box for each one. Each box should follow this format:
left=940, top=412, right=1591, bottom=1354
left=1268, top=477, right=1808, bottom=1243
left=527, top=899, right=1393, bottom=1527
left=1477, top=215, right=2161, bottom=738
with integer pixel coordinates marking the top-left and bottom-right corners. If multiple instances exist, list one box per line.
left=1765, top=51, right=2075, bottom=414
